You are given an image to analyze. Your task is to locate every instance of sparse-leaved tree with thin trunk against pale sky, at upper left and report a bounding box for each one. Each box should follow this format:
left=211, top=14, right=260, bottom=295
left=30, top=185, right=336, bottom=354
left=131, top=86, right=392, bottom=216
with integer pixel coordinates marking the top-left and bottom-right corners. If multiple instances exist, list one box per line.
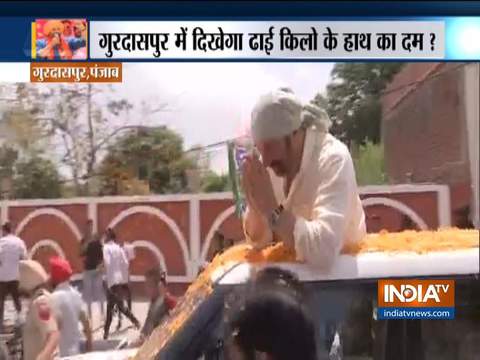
left=3, top=84, right=132, bottom=196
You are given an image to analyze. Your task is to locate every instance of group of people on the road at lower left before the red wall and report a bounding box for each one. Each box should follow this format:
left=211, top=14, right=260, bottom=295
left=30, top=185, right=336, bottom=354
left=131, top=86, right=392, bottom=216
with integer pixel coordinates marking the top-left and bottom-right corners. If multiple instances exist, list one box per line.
left=0, top=220, right=177, bottom=360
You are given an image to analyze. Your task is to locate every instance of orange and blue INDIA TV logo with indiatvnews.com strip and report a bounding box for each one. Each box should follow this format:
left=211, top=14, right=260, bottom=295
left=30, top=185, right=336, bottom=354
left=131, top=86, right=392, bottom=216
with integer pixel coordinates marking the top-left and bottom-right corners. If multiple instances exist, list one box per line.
left=377, top=279, right=455, bottom=319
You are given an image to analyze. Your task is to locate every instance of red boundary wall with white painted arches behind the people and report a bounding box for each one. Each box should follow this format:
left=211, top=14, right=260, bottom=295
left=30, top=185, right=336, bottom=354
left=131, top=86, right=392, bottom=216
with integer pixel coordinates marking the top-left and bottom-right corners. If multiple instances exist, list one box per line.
left=0, top=185, right=451, bottom=292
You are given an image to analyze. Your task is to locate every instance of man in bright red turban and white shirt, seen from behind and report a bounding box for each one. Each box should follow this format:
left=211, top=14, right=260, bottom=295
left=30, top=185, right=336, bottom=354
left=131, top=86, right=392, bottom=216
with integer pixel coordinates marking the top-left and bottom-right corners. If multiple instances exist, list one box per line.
left=49, top=256, right=92, bottom=357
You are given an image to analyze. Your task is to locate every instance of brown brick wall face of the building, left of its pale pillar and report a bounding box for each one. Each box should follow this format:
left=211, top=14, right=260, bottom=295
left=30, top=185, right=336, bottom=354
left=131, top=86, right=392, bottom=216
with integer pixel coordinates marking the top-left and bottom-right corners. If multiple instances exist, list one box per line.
left=382, top=63, right=470, bottom=184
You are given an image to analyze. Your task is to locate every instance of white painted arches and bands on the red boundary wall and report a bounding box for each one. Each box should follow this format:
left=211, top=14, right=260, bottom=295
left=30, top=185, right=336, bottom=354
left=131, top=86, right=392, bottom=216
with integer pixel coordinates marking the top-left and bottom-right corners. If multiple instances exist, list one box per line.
left=4, top=184, right=451, bottom=282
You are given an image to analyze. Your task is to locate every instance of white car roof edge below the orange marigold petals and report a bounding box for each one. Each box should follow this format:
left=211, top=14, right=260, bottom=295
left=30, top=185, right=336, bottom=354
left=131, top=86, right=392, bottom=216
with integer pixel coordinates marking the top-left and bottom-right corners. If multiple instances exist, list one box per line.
left=216, top=248, right=480, bottom=285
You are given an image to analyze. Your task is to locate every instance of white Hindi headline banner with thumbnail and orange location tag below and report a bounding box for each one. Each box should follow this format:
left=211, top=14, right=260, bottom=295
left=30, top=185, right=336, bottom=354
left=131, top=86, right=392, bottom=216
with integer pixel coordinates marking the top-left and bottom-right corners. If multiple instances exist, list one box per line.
left=3, top=17, right=472, bottom=83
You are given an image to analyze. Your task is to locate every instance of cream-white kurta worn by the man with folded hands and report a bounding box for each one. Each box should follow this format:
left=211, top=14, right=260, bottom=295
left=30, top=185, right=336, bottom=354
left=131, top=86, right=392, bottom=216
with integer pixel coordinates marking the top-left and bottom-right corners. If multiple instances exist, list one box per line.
left=246, top=129, right=366, bottom=270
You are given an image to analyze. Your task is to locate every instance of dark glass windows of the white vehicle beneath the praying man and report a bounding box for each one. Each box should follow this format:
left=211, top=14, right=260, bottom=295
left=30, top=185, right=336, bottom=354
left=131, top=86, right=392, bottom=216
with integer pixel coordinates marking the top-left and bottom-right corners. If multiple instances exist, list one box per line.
left=164, top=277, right=480, bottom=360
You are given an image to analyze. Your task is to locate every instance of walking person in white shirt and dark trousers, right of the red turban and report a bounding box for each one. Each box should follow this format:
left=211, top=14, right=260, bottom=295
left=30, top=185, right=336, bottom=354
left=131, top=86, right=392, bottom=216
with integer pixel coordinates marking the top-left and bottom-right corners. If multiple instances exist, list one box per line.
left=103, top=229, right=140, bottom=339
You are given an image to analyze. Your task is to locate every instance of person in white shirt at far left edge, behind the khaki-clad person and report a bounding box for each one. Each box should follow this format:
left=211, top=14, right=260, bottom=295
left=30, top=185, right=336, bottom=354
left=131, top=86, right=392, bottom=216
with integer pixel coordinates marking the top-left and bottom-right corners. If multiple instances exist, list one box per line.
left=0, top=222, right=27, bottom=327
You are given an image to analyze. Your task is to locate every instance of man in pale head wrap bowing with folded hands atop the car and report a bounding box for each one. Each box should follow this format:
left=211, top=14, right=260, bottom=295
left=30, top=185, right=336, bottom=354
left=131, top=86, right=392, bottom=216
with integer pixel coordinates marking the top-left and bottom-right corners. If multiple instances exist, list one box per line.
left=242, top=89, right=366, bottom=271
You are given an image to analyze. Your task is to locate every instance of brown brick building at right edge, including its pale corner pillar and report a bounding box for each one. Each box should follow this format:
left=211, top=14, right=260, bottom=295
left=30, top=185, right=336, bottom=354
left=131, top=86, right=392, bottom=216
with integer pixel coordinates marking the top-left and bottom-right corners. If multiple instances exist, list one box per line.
left=382, top=63, right=480, bottom=227
